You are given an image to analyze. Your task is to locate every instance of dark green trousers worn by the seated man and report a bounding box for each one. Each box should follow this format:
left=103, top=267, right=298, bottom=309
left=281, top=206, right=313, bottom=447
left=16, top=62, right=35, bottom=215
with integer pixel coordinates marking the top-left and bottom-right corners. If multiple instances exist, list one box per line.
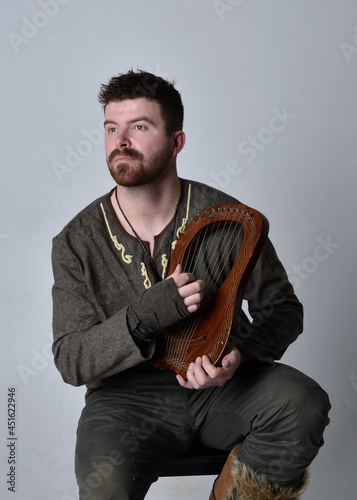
left=76, top=364, right=330, bottom=500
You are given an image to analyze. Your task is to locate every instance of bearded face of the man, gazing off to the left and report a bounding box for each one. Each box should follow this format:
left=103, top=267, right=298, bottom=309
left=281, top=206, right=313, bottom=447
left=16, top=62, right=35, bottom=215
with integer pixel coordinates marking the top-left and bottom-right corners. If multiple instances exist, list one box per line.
left=104, top=97, right=174, bottom=187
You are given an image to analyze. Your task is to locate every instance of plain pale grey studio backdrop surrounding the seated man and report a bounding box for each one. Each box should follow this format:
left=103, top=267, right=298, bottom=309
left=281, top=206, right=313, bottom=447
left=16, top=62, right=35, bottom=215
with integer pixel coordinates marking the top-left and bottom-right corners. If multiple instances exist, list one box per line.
left=0, top=0, right=357, bottom=500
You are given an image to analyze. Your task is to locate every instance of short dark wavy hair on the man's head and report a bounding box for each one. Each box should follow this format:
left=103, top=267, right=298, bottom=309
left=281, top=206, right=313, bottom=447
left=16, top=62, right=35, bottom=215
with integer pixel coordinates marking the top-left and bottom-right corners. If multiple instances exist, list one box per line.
left=98, top=70, right=184, bottom=134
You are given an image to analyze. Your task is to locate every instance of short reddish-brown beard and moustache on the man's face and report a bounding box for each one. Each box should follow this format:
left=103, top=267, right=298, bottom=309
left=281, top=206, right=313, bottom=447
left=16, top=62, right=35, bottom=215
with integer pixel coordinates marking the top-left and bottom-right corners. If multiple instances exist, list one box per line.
left=107, top=148, right=171, bottom=187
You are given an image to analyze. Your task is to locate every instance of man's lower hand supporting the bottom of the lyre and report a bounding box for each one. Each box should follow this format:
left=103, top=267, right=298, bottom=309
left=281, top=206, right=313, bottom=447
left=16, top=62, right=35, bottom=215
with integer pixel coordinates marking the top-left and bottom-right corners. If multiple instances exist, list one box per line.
left=176, top=347, right=242, bottom=389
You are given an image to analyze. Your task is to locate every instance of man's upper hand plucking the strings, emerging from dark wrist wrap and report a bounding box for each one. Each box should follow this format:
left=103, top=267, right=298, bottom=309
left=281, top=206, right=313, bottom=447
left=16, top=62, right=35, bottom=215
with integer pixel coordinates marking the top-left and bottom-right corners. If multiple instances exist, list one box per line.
left=167, top=264, right=205, bottom=313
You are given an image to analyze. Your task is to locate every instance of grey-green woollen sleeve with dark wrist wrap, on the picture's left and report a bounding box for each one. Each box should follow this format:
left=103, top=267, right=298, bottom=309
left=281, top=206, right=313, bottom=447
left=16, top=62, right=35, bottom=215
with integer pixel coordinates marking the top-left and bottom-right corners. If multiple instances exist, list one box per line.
left=52, top=234, right=188, bottom=386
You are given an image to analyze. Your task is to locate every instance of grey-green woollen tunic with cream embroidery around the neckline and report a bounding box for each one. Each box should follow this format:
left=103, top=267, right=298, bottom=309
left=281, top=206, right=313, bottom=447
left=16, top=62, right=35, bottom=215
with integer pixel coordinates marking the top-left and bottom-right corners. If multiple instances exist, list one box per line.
left=52, top=180, right=302, bottom=389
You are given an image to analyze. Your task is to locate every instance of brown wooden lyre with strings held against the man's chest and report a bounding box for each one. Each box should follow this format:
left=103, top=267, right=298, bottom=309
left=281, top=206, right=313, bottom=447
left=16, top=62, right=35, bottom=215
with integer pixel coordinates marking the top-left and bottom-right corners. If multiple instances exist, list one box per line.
left=152, top=205, right=269, bottom=377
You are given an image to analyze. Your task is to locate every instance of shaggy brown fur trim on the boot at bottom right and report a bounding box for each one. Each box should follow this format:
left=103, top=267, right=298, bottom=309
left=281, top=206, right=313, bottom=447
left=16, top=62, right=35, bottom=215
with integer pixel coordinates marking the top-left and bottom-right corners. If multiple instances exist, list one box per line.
left=224, top=457, right=308, bottom=500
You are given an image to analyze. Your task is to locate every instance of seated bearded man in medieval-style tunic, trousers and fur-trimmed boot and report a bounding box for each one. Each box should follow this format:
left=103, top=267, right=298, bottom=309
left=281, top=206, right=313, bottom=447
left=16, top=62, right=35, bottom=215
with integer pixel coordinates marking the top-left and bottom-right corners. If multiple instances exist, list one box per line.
left=53, top=71, right=329, bottom=500
